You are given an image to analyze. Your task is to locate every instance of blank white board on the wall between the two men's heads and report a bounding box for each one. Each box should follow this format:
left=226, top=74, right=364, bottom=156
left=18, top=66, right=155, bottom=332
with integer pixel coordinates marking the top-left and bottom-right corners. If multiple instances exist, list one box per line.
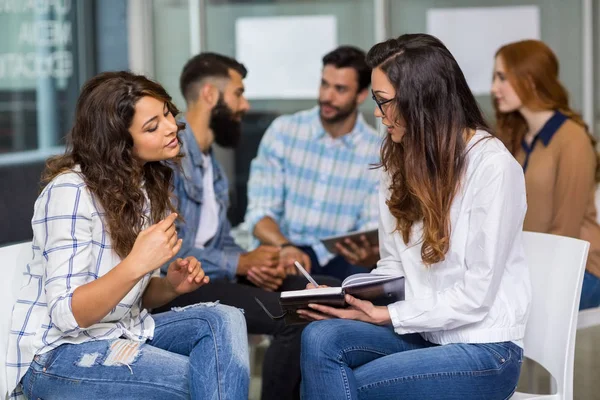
left=235, top=15, right=337, bottom=99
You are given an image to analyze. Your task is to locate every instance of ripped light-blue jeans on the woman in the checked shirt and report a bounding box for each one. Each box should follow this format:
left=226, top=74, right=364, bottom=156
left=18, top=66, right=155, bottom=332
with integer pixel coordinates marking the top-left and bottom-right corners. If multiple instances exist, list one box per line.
left=21, top=303, right=250, bottom=400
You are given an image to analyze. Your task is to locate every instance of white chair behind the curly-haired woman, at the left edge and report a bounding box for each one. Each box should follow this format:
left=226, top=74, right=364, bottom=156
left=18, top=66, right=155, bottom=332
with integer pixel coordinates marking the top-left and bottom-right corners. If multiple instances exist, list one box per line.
left=0, top=242, right=33, bottom=399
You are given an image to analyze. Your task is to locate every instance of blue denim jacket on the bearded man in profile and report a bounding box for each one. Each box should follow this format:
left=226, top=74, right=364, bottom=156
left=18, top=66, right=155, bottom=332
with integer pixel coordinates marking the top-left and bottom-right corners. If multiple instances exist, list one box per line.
left=162, top=118, right=244, bottom=280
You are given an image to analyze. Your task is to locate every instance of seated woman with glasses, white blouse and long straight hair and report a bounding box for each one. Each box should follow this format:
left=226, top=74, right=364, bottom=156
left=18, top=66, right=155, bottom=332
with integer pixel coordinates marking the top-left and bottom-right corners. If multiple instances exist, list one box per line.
left=299, top=34, right=531, bottom=400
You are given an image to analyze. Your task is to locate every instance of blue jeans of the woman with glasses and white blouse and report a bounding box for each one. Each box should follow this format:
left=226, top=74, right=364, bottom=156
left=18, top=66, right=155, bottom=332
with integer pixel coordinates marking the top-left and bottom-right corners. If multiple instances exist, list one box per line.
left=301, top=319, right=523, bottom=400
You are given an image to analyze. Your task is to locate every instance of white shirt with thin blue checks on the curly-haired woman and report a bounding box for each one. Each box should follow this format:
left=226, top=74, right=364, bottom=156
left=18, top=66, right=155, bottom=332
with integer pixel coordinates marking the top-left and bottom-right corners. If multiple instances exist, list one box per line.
left=6, top=170, right=158, bottom=398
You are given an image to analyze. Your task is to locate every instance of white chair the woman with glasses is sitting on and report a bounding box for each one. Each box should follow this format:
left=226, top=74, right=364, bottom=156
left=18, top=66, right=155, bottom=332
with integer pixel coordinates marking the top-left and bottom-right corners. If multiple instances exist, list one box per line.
left=511, top=232, right=590, bottom=400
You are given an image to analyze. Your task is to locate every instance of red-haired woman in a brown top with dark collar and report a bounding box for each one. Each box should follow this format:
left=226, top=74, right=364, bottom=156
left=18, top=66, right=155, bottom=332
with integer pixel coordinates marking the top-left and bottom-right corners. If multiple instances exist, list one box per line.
left=492, top=40, right=600, bottom=310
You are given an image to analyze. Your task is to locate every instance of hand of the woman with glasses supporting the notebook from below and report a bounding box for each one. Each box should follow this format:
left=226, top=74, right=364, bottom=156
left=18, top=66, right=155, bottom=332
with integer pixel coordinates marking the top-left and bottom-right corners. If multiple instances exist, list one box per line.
left=296, top=294, right=391, bottom=325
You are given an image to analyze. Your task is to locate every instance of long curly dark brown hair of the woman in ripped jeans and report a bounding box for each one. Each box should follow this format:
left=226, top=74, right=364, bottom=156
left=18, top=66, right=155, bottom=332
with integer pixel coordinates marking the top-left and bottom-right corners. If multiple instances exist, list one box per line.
left=42, top=71, right=183, bottom=258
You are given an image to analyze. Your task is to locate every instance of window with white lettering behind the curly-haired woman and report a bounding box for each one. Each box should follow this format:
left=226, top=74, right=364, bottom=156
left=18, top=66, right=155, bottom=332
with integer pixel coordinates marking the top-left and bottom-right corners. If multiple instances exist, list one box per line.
left=0, top=0, right=81, bottom=158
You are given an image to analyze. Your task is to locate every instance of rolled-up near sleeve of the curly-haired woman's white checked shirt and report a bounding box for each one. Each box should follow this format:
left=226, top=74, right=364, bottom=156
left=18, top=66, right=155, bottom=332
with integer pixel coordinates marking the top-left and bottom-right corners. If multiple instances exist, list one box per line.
left=33, top=183, right=95, bottom=337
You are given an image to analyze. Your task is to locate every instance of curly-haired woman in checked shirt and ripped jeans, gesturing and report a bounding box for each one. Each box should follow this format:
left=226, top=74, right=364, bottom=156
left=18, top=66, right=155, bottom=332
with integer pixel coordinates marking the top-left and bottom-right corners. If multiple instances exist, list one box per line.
left=7, top=72, right=249, bottom=399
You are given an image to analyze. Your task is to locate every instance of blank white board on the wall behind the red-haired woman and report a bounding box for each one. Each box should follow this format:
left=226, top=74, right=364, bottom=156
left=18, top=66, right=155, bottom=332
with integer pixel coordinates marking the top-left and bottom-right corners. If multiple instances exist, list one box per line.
left=427, top=6, right=540, bottom=95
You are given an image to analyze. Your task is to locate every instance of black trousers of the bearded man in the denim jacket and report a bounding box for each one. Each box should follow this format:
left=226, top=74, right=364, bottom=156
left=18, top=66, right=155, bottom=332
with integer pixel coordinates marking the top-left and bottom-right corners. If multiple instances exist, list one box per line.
left=153, top=275, right=340, bottom=400
